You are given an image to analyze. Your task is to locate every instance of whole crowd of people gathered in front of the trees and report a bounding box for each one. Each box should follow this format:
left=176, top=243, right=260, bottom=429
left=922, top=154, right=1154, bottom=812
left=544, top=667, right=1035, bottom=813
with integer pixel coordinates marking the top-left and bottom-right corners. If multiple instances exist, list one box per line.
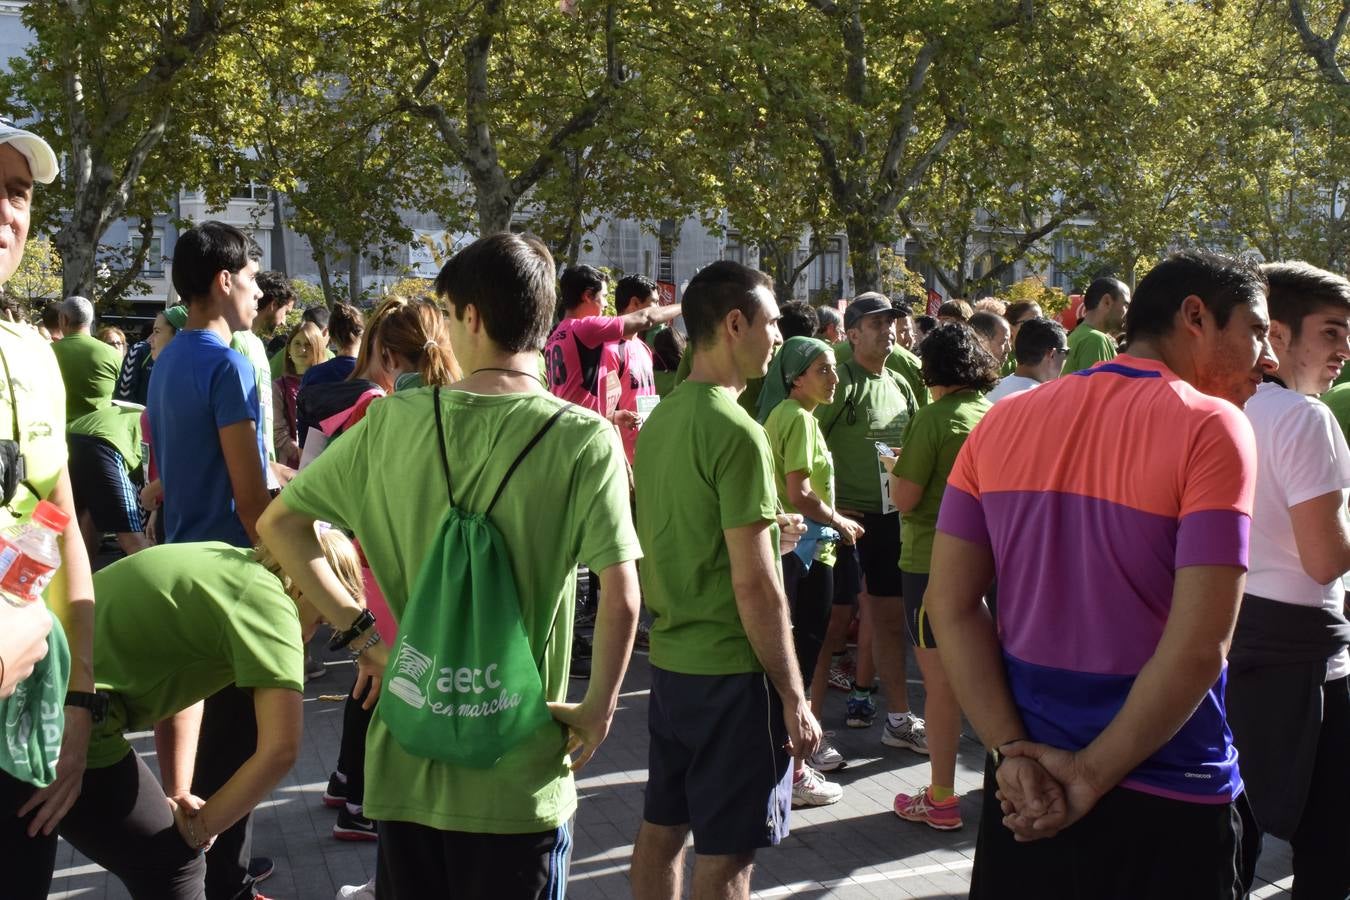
left=0, top=119, right=1350, bottom=900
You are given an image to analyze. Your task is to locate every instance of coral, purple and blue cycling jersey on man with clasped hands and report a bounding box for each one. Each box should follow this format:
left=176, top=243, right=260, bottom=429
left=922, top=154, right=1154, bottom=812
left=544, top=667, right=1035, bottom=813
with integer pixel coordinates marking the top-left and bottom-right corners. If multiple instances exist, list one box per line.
left=938, top=356, right=1257, bottom=803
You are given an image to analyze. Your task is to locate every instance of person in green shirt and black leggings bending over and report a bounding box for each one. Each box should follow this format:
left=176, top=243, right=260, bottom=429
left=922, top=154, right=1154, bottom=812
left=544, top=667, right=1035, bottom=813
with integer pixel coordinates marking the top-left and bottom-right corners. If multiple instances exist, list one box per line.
left=21, top=529, right=377, bottom=900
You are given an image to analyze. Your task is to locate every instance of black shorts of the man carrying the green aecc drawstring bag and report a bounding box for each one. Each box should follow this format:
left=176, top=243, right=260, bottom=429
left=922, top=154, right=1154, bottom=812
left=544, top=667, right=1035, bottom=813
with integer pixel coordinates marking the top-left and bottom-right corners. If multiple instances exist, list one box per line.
left=375, top=822, right=572, bottom=900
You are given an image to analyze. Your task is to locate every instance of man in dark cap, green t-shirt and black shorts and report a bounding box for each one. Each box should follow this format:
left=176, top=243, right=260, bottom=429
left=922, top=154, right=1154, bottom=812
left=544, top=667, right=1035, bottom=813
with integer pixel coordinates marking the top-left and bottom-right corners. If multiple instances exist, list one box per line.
left=815, top=293, right=927, bottom=753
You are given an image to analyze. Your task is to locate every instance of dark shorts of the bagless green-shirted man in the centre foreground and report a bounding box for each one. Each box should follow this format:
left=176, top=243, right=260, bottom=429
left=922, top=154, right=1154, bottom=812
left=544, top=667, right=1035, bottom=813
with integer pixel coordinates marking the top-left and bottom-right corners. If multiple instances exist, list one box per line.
left=643, top=665, right=792, bottom=855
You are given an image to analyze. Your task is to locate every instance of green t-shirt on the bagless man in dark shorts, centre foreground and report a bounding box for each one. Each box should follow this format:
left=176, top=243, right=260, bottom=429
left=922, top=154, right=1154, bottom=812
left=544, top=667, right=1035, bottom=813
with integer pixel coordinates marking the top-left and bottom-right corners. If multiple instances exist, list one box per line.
left=633, top=381, right=778, bottom=675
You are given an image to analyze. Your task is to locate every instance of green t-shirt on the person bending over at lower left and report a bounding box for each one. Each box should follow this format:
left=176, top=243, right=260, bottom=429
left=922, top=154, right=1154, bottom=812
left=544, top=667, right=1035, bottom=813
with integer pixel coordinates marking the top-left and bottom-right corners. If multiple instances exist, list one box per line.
left=89, top=541, right=305, bottom=769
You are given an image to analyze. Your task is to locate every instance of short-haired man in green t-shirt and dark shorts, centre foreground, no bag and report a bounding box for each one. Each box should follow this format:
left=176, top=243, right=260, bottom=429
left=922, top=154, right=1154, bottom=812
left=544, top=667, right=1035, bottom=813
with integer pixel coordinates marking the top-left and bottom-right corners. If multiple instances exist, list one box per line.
left=632, top=260, right=821, bottom=897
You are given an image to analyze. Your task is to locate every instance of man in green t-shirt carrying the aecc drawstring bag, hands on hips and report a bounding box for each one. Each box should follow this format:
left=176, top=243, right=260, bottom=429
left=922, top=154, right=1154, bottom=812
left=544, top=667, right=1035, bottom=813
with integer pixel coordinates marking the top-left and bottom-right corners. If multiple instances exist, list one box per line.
left=258, top=233, right=641, bottom=897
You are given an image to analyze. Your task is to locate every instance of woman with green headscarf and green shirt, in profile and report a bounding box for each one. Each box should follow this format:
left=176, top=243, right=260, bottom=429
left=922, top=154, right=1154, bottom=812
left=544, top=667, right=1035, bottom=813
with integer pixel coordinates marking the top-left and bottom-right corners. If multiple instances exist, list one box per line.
left=759, top=337, right=863, bottom=806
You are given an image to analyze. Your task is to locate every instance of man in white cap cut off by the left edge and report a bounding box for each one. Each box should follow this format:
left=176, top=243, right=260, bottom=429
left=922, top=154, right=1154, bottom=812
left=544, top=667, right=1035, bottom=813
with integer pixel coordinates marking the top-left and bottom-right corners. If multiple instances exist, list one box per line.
left=0, top=119, right=99, bottom=900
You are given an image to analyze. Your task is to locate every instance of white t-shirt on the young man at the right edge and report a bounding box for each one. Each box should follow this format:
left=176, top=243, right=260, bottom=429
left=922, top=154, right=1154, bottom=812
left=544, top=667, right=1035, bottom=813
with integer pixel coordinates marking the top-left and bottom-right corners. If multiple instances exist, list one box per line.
left=1246, top=383, right=1350, bottom=681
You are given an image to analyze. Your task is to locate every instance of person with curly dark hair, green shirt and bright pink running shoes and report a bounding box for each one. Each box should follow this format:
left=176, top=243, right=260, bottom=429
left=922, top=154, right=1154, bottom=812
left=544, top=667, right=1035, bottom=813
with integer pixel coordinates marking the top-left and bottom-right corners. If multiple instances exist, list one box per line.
left=886, top=322, right=999, bottom=831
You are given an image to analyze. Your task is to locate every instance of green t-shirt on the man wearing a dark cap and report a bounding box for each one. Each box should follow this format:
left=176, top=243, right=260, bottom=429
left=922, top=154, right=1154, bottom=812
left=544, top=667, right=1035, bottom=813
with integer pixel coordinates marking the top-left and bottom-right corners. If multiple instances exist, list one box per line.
left=815, top=360, right=918, bottom=513
